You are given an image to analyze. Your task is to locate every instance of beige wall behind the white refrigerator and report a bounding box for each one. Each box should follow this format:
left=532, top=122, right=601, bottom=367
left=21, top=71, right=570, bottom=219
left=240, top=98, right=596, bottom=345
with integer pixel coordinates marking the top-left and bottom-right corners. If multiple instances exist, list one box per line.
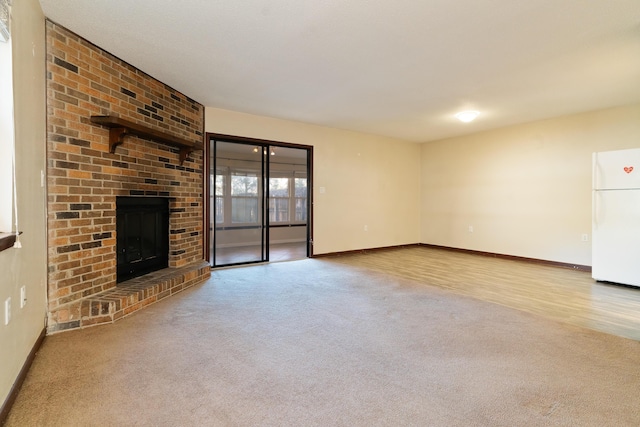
left=420, top=105, right=640, bottom=265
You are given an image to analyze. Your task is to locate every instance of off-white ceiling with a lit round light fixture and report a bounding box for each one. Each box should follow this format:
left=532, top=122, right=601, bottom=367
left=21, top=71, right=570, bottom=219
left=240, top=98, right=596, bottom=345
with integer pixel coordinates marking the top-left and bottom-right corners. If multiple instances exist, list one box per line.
left=40, top=0, right=640, bottom=142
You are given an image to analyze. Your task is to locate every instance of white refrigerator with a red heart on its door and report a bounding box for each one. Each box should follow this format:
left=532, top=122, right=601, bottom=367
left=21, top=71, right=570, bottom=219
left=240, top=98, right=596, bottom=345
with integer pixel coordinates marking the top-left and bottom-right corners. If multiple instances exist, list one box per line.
left=592, top=149, right=640, bottom=287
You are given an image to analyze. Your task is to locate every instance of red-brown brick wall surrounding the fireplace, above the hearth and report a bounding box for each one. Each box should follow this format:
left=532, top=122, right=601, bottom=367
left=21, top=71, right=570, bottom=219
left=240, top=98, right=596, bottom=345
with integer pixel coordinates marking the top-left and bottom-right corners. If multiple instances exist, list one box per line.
left=46, top=21, right=204, bottom=331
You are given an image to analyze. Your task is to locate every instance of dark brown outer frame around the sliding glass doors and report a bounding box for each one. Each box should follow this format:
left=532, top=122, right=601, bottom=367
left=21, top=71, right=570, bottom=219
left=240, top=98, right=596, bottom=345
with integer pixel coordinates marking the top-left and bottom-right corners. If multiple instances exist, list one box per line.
left=202, top=132, right=313, bottom=268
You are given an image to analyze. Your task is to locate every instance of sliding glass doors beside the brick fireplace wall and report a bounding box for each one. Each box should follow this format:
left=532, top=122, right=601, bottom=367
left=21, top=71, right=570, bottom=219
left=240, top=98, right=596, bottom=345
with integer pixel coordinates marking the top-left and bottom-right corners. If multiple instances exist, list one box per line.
left=207, top=134, right=312, bottom=267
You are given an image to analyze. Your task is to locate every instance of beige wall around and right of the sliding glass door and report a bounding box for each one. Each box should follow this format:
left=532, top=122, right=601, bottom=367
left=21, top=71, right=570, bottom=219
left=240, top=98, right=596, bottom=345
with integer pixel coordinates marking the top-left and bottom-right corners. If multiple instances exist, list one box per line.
left=205, top=108, right=420, bottom=254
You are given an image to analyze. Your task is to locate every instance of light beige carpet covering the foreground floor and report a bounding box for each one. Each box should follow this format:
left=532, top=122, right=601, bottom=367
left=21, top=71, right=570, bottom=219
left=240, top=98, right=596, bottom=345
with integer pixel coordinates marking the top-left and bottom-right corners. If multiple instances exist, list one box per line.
left=7, top=259, right=640, bottom=426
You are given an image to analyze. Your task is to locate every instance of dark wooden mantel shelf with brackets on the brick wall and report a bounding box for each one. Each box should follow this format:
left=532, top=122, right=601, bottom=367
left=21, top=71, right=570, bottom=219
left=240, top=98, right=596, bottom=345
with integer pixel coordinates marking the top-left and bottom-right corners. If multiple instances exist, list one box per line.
left=91, top=116, right=202, bottom=164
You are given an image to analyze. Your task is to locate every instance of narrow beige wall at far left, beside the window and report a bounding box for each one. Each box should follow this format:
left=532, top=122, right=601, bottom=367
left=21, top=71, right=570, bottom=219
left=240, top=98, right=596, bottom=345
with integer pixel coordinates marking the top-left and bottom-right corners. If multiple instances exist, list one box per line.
left=0, top=0, right=47, bottom=412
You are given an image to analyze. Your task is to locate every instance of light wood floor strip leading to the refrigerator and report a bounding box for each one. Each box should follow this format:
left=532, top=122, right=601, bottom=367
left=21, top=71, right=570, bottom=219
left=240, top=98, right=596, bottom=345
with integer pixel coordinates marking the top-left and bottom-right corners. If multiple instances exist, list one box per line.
left=323, top=246, right=640, bottom=341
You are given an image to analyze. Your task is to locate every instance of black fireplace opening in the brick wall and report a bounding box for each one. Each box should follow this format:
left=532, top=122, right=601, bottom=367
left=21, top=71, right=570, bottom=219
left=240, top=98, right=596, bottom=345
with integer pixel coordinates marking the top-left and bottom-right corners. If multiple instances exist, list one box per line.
left=116, top=197, right=169, bottom=283
